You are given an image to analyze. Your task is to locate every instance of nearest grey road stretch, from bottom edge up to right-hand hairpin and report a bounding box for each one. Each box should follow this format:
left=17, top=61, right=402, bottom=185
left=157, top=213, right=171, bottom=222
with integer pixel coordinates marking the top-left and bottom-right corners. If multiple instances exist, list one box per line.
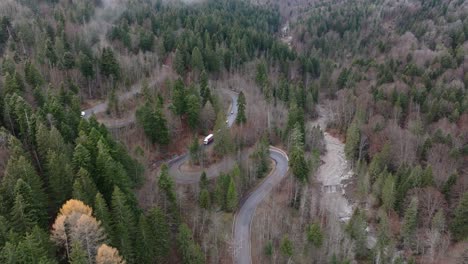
left=233, top=147, right=289, bottom=264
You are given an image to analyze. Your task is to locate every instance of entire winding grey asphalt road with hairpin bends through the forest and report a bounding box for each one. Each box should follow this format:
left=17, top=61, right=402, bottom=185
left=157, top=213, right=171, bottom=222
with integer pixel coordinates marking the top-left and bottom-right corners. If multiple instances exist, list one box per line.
left=83, top=85, right=289, bottom=264
